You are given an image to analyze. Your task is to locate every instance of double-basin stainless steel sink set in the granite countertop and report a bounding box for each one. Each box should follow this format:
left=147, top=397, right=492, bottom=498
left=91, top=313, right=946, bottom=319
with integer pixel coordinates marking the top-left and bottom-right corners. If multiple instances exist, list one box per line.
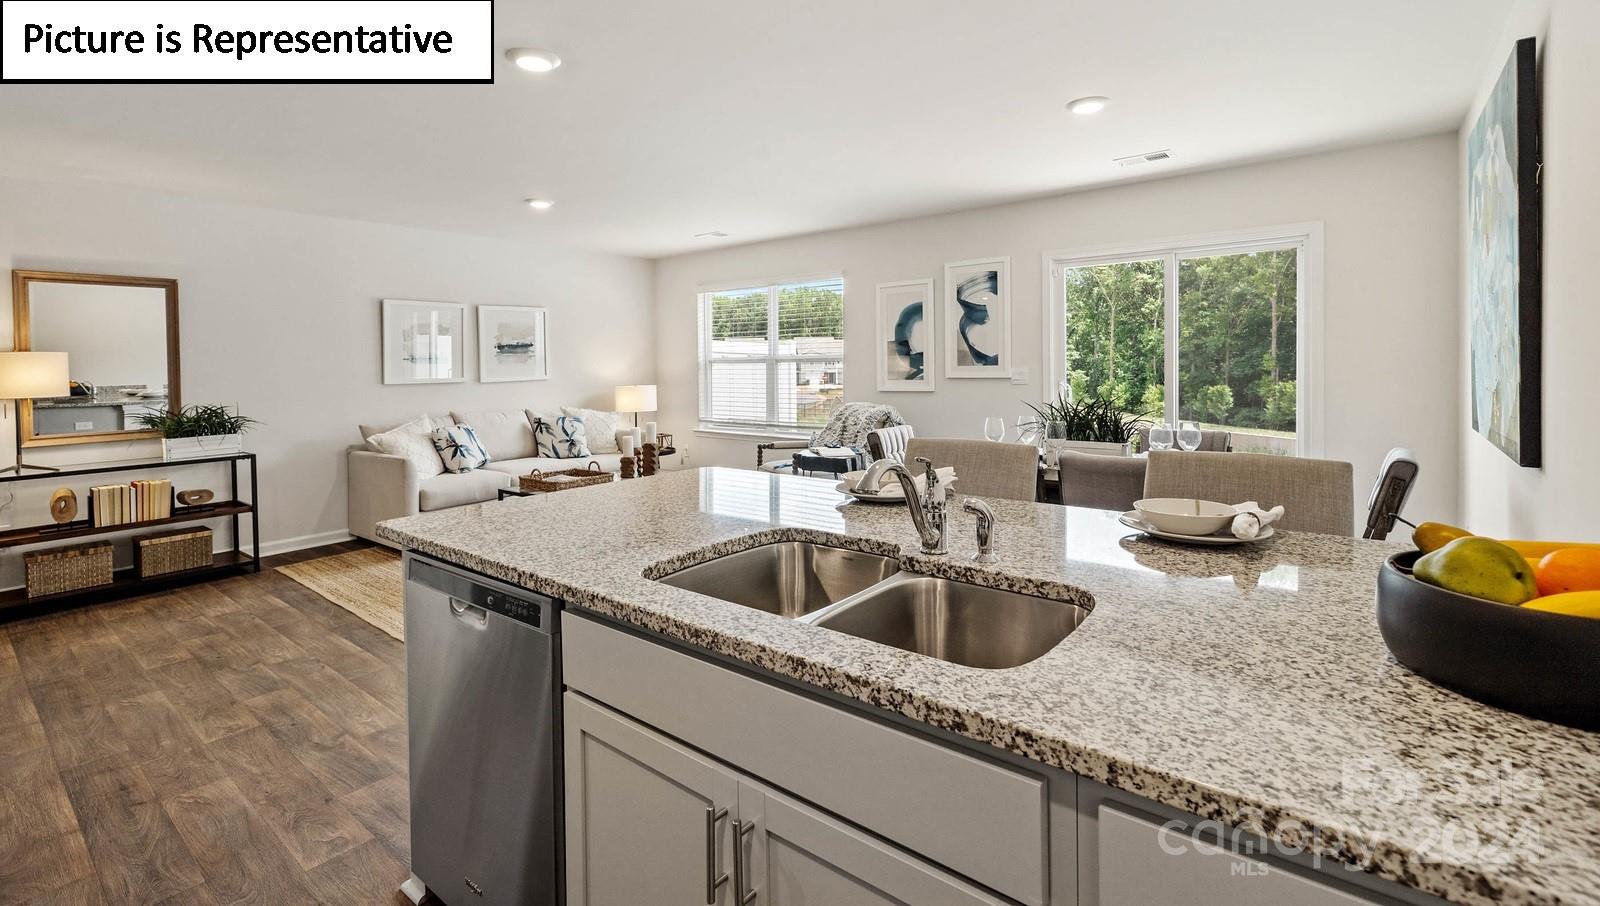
left=658, top=541, right=1088, bottom=669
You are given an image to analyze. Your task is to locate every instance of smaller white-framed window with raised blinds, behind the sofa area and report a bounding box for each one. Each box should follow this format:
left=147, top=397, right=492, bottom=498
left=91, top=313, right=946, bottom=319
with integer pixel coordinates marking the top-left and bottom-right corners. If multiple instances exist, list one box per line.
left=699, top=279, right=845, bottom=431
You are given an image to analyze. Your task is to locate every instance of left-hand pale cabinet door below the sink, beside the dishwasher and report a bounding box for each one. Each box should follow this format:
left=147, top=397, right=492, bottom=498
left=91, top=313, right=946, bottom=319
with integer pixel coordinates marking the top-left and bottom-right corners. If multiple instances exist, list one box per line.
left=563, top=693, right=739, bottom=906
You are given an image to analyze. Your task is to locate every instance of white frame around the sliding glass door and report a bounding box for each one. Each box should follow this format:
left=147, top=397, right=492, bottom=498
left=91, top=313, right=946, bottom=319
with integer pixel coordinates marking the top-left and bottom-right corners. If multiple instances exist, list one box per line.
left=1042, top=221, right=1325, bottom=456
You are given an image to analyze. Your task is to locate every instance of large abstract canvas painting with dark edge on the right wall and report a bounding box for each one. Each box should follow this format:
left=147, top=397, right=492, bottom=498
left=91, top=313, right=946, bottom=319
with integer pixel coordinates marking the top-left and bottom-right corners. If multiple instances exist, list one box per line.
left=1467, top=38, right=1541, bottom=466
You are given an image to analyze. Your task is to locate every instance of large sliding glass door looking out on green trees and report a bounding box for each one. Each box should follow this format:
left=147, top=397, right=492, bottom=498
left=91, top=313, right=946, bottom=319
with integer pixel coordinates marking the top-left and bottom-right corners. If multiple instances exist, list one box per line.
left=1046, top=226, right=1320, bottom=455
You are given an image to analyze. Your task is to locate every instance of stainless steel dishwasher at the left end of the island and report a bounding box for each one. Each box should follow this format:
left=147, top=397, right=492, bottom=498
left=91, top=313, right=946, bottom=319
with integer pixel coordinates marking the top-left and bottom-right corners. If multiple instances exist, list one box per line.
left=402, top=554, right=563, bottom=906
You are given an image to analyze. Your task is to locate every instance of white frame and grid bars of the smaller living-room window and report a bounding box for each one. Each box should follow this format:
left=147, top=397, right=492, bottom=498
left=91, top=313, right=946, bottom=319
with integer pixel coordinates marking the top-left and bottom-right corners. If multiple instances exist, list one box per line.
left=694, top=272, right=848, bottom=437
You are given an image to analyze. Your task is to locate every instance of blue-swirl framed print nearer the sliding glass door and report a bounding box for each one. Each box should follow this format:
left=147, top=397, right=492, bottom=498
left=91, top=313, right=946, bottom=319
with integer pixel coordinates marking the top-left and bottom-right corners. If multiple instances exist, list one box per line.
left=939, top=258, right=1011, bottom=379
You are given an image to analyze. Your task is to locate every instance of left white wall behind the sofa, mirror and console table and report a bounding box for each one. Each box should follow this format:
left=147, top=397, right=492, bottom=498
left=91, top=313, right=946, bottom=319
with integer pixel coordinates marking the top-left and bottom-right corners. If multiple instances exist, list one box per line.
left=0, top=179, right=654, bottom=563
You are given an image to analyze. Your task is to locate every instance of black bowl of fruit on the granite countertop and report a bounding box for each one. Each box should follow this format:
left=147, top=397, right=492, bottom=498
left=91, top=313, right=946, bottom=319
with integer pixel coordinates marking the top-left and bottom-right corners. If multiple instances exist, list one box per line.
left=1378, top=523, right=1600, bottom=730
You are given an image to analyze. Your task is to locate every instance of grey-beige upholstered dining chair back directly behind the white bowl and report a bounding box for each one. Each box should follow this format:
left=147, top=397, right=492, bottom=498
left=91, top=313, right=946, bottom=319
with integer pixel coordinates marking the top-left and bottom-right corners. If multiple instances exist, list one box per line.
left=1144, top=450, right=1355, bottom=536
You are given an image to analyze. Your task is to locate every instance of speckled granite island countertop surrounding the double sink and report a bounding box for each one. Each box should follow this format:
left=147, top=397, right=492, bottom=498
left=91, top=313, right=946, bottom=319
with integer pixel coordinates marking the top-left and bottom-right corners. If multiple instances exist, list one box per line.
left=378, top=469, right=1600, bottom=904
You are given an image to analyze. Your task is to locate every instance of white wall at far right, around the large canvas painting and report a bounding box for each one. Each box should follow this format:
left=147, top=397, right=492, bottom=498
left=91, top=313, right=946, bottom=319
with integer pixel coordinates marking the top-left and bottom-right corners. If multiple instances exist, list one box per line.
left=1456, top=0, right=1600, bottom=541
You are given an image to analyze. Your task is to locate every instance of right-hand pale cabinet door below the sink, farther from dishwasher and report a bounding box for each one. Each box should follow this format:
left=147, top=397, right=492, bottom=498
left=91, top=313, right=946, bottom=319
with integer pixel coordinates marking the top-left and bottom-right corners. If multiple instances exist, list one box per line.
left=733, top=781, right=1005, bottom=906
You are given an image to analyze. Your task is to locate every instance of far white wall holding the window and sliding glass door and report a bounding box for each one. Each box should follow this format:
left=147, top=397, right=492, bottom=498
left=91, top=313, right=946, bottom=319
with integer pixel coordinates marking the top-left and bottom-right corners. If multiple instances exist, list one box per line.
left=656, top=134, right=1459, bottom=520
